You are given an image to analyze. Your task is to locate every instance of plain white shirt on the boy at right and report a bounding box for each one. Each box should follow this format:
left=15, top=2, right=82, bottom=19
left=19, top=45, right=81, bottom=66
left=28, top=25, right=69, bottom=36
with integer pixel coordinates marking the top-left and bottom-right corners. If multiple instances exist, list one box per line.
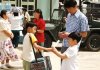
left=61, top=45, right=79, bottom=70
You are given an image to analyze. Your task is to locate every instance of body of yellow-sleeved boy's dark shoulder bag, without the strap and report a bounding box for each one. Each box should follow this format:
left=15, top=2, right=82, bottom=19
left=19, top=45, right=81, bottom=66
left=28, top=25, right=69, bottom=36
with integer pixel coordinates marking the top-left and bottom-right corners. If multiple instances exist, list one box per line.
left=31, top=56, right=52, bottom=70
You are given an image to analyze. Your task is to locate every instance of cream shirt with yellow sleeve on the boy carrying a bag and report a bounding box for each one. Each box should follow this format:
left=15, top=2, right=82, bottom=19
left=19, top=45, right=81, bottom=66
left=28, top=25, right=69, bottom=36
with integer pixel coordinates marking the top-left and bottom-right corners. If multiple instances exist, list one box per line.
left=22, top=33, right=37, bottom=62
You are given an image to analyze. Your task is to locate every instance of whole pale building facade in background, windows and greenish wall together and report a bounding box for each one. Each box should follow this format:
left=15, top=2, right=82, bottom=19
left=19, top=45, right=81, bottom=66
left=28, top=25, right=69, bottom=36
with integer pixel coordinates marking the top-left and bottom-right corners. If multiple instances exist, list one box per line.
left=0, top=0, right=59, bottom=20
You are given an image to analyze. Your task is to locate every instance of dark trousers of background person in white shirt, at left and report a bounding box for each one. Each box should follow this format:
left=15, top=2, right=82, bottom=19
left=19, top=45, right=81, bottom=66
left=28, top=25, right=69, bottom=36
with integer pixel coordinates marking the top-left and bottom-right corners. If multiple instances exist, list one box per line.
left=12, top=30, right=20, bottom=48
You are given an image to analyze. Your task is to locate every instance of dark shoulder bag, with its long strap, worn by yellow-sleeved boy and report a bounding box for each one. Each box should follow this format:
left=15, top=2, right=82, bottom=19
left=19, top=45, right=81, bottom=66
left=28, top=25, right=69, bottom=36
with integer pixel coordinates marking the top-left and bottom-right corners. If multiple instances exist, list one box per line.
left=30, top=37, right=52, bottom=70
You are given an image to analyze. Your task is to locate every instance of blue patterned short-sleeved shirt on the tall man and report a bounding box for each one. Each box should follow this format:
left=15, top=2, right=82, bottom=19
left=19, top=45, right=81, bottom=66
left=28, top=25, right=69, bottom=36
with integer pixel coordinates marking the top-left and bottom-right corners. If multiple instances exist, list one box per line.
left=63, top=10, right=89, bottom=47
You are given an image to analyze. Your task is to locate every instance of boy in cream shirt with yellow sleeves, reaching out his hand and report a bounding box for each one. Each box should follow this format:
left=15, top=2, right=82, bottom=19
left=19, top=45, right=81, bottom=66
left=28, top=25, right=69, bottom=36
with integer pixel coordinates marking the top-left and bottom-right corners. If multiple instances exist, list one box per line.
left=22, top=22, right=52, bottom=70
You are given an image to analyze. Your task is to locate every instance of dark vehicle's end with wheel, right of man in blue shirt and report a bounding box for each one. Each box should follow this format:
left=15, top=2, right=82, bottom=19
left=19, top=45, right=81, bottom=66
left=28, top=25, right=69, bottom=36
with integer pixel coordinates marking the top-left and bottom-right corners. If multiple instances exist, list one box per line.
left=81, top=2, right=100, bottom=51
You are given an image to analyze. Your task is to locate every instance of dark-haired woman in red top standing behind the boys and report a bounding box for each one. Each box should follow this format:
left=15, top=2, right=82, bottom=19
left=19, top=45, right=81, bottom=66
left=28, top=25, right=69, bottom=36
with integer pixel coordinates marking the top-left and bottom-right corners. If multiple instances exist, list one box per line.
left=33, top=9, right=45, bottom=46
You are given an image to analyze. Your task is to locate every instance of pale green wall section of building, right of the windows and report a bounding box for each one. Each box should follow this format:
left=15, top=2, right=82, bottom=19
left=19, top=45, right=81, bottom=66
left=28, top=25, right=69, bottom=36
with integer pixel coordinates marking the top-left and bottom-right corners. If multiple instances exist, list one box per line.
left=37, top=0, right=59, bottom=20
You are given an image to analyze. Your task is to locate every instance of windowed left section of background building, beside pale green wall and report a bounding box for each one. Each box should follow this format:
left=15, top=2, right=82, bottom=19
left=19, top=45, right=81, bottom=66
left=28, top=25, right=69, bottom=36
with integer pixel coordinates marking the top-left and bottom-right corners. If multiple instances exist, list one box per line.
left=0, top=0, right=35, bottom=18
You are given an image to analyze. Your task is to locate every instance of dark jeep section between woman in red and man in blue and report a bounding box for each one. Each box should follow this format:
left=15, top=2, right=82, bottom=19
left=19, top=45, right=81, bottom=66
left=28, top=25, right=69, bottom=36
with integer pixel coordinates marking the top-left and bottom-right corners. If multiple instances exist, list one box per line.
left=44, top=9, right=65, bottom=47
